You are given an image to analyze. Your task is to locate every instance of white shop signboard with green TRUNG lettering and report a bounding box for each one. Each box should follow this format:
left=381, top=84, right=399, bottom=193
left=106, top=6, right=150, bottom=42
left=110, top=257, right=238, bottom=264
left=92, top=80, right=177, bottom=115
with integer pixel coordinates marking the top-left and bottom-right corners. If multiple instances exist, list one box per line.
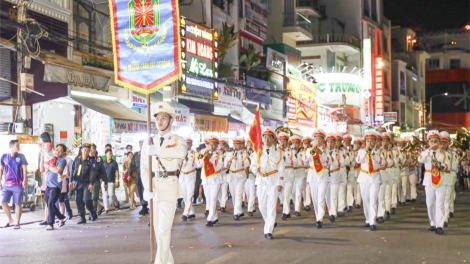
left=313, top=73, right=364, bottom=121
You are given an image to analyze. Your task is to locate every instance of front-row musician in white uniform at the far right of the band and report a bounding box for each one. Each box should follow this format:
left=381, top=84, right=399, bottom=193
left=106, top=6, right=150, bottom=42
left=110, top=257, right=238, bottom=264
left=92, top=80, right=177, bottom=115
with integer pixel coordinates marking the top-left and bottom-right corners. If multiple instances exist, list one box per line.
left=418, top=130, right=451, bottom=235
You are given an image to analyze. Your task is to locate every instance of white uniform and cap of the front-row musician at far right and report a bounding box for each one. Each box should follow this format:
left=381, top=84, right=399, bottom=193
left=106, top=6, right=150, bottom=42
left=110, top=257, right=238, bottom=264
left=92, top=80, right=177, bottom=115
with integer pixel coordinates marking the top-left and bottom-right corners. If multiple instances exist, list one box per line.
left=418, top=130, right=450, bottom=232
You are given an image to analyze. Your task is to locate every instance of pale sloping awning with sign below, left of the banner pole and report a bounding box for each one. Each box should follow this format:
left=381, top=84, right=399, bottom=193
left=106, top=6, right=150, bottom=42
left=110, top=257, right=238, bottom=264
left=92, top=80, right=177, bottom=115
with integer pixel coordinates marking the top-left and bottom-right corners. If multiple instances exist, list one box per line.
left=72, top=96, right=155, bottom=133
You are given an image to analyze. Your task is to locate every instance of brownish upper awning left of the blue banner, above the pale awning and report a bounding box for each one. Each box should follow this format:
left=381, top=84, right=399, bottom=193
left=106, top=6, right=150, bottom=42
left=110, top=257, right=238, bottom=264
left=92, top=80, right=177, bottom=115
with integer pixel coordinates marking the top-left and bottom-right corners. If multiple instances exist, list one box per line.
left=0, top=38, right=114, bottom=92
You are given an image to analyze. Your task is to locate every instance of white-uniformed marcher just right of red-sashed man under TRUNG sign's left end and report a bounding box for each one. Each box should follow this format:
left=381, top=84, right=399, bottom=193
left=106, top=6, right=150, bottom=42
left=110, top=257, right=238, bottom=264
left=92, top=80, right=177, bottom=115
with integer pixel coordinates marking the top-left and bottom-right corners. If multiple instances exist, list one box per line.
left=325, top=133, right=345, bottom=222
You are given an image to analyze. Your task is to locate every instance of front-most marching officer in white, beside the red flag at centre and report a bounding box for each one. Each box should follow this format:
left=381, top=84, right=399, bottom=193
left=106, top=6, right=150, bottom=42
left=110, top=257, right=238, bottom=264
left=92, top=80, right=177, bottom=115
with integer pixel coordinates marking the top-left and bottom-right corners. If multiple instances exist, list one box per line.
left=251, top=126, right=285, bottom=239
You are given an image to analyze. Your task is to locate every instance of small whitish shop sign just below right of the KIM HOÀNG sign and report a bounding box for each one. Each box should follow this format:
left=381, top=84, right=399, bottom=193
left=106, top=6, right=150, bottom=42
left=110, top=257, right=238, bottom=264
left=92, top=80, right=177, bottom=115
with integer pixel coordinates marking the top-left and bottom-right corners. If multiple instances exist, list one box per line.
left=214, top=83, right=246, bottom=115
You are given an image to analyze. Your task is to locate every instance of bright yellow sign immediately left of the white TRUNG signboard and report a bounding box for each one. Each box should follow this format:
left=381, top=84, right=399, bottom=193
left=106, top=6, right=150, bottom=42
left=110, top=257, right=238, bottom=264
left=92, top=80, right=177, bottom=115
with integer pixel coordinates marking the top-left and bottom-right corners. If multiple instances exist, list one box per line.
left=287, top=77, right=317, bottom=110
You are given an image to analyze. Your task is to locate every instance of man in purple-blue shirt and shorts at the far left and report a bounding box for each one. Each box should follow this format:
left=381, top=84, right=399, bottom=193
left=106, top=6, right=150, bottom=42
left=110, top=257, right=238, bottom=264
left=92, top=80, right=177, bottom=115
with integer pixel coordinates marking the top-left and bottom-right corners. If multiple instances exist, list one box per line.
left=0, top=140, right=28, bottom=229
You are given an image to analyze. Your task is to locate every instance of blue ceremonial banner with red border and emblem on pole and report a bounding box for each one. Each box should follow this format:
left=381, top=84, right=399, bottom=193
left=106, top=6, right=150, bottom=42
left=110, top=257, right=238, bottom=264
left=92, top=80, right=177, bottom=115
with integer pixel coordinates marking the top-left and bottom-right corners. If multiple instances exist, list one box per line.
left=109, top=0, right=181, bottom=94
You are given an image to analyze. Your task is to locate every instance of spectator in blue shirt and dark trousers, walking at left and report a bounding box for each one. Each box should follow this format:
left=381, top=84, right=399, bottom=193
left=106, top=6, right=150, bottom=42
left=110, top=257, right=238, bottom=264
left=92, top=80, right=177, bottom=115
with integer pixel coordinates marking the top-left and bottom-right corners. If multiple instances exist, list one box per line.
left=40, top=144, right=67, bottom=230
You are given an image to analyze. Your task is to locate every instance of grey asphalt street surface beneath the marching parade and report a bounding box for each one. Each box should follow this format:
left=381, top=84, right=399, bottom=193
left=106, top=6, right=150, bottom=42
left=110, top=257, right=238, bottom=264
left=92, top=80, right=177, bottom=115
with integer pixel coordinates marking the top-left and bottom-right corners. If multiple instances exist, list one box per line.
left=0, top=189, right=470, bottom=264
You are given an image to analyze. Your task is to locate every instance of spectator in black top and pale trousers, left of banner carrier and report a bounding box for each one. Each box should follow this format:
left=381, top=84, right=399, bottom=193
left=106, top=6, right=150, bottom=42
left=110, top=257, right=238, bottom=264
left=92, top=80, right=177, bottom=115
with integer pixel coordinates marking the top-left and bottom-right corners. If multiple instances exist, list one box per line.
left=103, top=149, right=119, bottom=211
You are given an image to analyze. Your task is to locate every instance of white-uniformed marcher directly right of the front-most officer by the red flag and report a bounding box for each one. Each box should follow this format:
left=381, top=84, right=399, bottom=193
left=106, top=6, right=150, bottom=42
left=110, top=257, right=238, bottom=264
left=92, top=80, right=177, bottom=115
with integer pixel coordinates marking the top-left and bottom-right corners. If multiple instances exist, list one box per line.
left=277, top=132, right=297, bottom=220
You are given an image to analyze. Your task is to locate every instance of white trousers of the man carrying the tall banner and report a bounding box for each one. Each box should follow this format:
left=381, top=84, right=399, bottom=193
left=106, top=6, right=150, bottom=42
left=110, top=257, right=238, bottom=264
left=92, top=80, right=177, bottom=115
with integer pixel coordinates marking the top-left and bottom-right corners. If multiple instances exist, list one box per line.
left=153, top=199, right=176, bottom=264
